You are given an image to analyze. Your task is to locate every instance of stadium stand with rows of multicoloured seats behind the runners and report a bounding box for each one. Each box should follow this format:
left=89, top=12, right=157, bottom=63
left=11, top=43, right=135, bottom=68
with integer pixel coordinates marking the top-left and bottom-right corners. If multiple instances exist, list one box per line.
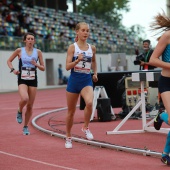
left=0, top=2, right=140, bottom=54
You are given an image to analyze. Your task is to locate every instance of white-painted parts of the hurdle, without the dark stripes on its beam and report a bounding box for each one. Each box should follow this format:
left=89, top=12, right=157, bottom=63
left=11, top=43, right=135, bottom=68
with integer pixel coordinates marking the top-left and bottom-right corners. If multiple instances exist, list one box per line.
left=106, top=72, right=170, bottom=135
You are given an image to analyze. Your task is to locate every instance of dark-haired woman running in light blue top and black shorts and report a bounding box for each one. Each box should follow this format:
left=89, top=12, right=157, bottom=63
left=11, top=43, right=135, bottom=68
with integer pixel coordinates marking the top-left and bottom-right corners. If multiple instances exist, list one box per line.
left=7, top=33, right=45, bottom=135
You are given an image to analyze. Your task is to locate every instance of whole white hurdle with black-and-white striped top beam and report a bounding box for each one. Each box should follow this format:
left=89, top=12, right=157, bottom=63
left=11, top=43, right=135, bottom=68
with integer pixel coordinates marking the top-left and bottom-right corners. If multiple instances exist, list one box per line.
left=106, top=71, right=170, bottom=135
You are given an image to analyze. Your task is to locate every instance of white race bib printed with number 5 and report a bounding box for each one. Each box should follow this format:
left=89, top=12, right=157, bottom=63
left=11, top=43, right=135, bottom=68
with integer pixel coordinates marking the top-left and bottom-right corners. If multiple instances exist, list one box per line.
left=74, top=58, right=91, bottom=74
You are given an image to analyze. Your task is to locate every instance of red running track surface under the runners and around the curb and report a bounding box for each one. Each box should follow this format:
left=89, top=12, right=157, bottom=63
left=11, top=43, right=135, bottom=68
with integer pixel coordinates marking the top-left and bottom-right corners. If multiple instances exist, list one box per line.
left=0, top=88, right=169, bottom=170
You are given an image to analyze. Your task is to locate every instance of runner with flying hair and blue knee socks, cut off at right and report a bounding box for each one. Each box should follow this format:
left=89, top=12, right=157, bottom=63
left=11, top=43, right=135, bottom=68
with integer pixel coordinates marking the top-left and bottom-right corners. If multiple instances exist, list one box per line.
left=149, top=11, right=170, bottom=165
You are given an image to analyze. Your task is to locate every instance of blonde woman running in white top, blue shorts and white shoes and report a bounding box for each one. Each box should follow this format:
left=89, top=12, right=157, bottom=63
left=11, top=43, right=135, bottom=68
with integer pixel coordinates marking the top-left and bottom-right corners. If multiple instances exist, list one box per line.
left=65, top=22, right=98, bottom=148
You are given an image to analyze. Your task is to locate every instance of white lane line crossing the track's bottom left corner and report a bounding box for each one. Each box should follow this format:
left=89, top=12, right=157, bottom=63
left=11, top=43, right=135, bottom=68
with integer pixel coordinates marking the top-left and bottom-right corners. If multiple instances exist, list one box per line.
left=0, top=151, right=77, bottom=170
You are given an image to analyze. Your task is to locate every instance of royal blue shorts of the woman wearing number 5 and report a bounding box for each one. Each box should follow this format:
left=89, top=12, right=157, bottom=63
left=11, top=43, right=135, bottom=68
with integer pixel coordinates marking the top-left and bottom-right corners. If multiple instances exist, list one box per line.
left=66, top=75, right=93, bottom=94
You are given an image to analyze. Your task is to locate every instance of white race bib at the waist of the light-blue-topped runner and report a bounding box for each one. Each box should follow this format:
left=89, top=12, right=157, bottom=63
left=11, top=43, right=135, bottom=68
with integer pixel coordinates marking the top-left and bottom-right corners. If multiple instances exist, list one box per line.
left=21, top=67, right=35, bottom=80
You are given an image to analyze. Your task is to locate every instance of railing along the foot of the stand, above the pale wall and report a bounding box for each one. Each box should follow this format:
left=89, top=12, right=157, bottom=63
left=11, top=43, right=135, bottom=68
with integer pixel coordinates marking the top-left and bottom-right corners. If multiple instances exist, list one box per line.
left=0, top=36, right=139, bottom=54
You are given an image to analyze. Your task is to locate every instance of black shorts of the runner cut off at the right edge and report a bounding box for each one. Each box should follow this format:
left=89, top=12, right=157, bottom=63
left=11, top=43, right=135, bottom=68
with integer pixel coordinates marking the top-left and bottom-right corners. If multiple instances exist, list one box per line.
left=158, top=75, right=170, bottom=93
